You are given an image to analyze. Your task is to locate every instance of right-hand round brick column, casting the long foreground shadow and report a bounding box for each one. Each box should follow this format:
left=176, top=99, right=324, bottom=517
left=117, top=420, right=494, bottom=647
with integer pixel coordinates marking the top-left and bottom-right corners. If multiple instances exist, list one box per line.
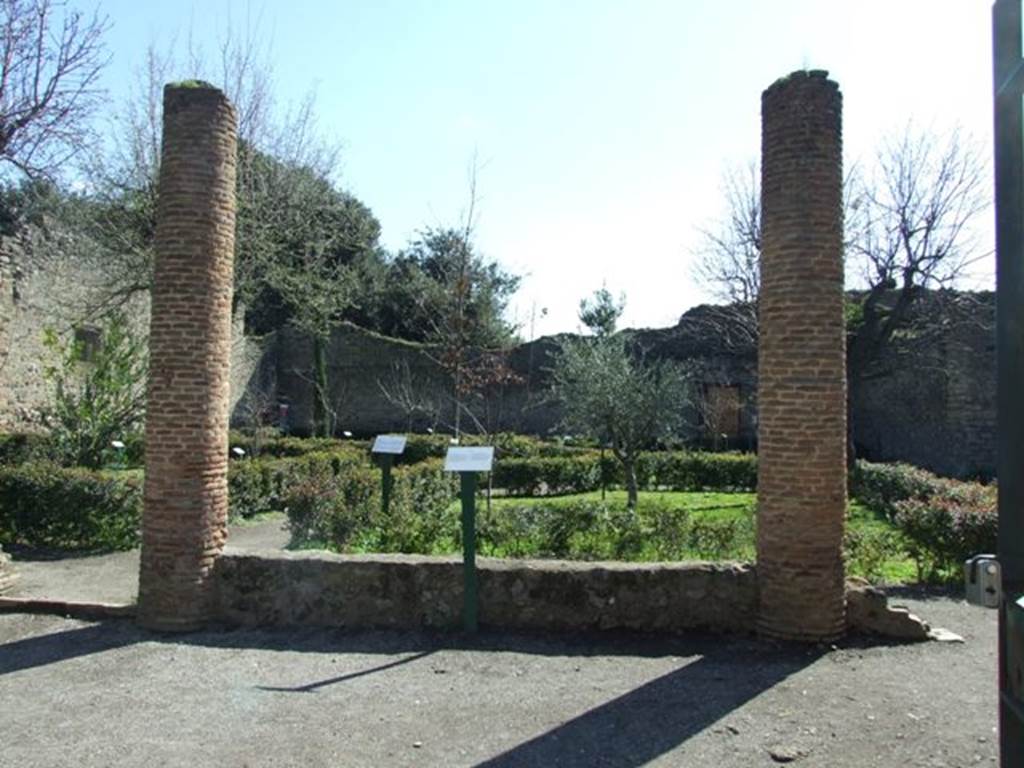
left=758, top=72, right=846, bottom=641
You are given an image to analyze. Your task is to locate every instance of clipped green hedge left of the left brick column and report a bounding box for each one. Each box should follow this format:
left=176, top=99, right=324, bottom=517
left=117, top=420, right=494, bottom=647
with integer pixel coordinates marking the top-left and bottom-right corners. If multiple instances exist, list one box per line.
left=0, top=462, right=142, bottom=551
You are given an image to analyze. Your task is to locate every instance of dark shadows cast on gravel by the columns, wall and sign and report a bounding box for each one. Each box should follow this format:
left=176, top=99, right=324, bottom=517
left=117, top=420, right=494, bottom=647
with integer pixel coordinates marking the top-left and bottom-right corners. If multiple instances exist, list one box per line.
left=0, top=621, right=913, bottom=768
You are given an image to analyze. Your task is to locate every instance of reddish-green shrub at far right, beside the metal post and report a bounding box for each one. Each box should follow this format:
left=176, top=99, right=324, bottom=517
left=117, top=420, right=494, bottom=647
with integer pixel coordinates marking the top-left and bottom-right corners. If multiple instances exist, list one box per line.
left=894, top=480, right=998, bottom=579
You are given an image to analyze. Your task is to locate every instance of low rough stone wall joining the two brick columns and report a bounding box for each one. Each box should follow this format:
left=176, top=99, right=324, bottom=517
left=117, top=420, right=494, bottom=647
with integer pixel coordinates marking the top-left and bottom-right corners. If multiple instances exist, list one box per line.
left=215, top=548, right=758, bottom=632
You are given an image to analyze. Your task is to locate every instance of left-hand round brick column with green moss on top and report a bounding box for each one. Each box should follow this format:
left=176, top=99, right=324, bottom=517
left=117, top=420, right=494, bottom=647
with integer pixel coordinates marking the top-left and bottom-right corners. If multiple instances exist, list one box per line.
left=138, top=84, right=237, bottom=630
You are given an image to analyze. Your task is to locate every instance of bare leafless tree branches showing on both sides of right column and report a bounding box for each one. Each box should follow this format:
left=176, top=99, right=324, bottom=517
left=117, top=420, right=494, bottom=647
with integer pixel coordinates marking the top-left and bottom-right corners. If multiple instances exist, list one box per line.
left=694, top=126, right=989, bottom=457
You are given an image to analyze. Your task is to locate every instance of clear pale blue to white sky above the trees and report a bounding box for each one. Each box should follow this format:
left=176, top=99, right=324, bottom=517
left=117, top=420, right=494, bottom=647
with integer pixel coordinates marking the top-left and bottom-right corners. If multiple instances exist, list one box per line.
left=83, top=0, right=991, bottom=337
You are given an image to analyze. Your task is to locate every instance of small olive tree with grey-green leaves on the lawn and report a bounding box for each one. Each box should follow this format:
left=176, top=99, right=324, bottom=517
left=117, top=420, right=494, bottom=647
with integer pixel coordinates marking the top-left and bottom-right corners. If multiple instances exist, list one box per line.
left=552, top=294, right=689, bottom=509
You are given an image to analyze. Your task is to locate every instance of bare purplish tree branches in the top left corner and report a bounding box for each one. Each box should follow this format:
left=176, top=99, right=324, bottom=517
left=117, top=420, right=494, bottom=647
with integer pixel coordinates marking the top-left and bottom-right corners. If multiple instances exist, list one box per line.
left=0, top=0, right=110, bottom=177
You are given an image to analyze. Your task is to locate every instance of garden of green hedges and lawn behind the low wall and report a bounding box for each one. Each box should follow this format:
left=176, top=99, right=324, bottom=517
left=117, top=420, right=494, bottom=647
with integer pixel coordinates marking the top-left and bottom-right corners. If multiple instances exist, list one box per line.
left=0, top=432, right=997, bottom=584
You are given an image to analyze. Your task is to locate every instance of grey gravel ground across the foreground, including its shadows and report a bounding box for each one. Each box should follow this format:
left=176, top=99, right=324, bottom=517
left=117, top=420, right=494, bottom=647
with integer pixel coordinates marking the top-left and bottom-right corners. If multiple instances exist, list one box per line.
left=0, top=594, right=997, bottom=768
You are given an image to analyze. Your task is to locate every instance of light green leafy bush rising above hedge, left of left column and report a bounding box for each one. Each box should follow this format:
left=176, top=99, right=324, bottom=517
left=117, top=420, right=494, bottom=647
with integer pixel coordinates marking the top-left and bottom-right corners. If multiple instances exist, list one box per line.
left=42, top=314, right=147, bottom=468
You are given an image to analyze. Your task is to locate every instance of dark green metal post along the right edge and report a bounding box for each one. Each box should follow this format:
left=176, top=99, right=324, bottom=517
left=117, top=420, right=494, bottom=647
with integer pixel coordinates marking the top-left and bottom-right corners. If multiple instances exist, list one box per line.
left=992, top=0, right=1024, bottom=768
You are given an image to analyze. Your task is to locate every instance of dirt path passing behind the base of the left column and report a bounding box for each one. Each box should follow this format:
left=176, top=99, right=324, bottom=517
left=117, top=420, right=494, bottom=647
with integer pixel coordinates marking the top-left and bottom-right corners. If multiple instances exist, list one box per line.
left=6, top=515, right=288, bottom=606
